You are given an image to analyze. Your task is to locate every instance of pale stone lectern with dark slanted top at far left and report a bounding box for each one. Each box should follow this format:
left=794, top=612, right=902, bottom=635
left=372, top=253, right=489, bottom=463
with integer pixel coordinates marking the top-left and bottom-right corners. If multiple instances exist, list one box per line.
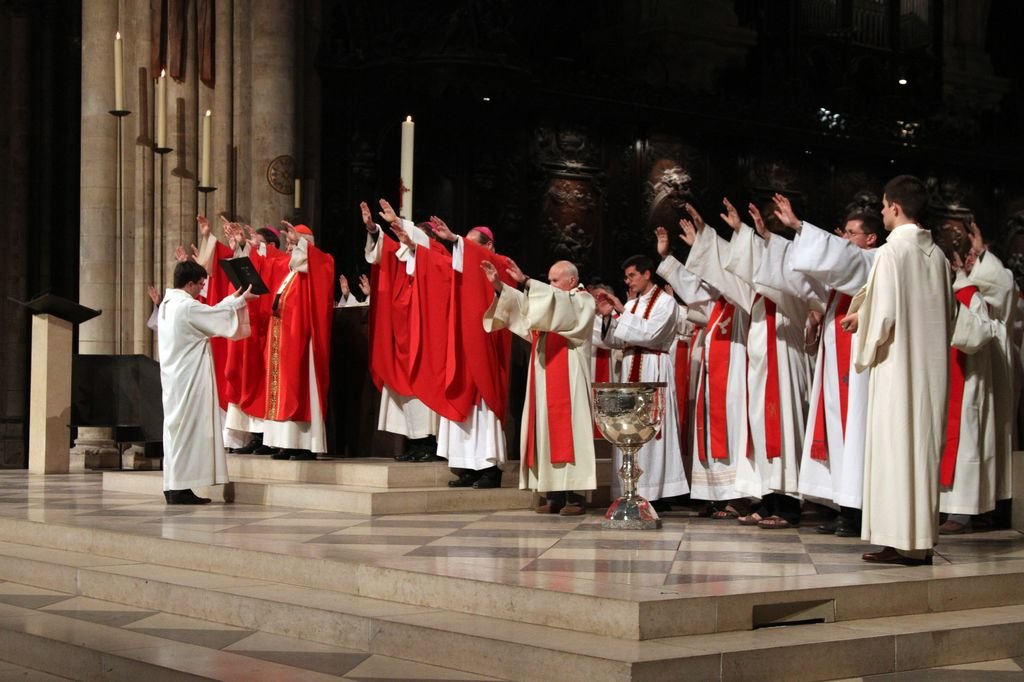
left=15, top=294, right=100, bottom=473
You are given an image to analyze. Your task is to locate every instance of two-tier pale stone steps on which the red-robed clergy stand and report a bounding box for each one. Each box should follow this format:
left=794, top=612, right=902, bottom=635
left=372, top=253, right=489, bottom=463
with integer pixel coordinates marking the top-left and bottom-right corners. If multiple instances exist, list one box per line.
left=102, top=455, right=611, bottom=515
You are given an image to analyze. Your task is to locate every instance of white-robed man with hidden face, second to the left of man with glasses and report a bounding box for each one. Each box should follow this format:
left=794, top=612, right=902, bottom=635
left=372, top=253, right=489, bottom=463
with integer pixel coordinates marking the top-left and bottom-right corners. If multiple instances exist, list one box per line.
left=655, top=227, right=750, bottom=512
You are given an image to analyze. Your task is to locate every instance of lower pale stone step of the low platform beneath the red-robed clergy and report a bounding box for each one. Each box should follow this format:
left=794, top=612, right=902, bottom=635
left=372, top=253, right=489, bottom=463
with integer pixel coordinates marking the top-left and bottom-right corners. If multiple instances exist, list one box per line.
left=103, top=471, right=536, bottom=515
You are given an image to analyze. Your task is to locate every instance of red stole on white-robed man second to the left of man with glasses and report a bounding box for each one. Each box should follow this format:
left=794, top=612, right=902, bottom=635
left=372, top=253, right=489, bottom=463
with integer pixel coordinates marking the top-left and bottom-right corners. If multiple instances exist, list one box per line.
left=693, top=297, right=736, bottom=462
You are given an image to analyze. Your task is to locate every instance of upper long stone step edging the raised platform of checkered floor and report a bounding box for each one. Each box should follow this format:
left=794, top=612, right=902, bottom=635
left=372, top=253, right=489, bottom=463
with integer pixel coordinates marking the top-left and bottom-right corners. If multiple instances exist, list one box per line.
left=0, top=518, right=1024, bottom=642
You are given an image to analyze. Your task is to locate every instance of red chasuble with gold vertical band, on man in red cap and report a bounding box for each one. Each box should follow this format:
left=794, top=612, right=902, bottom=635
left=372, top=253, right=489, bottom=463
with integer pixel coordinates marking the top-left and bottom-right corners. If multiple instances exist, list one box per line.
left=251, top=238, right=334, bottom=422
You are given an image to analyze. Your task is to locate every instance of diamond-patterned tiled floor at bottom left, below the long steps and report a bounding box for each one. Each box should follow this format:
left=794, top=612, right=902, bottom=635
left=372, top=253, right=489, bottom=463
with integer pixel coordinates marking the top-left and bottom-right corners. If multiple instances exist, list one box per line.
left=0, top=582, right=496, bottom=682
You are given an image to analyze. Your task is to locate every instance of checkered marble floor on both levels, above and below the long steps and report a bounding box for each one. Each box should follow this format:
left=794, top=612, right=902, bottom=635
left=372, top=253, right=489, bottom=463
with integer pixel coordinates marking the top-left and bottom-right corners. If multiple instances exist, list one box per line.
left=0, top=471, right=1024, bottom=682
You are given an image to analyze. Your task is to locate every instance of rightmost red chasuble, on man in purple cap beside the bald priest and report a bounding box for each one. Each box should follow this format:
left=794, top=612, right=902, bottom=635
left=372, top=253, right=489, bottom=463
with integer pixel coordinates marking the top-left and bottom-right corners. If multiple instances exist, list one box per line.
left=458, top=240, right=515, bottom=423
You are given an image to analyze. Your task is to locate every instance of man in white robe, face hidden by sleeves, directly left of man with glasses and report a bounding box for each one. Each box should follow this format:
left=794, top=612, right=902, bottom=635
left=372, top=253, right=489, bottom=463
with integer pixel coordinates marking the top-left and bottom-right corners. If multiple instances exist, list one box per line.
left=683, top=200, right=810, bottom=529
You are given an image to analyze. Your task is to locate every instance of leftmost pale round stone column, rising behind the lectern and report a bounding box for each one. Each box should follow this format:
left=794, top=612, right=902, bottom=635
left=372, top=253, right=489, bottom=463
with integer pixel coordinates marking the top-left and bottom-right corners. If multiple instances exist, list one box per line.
left=71, top=0, right=119, bottom=470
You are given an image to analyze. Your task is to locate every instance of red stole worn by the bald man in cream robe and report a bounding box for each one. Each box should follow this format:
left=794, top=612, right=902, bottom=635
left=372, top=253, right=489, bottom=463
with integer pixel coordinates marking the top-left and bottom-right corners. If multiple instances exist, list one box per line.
left=526, top=332, right=575, bottom=467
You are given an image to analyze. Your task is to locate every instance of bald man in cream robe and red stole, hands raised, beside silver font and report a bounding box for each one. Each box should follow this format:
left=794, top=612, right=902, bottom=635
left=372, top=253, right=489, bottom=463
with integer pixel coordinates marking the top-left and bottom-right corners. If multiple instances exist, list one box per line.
left=480, top=260, right=597, bottom=516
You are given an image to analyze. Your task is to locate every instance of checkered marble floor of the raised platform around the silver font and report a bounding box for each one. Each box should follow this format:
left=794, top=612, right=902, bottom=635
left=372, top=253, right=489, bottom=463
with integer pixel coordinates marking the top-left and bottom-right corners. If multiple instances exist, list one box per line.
left=0, top=471, right=1024, bottom=592
